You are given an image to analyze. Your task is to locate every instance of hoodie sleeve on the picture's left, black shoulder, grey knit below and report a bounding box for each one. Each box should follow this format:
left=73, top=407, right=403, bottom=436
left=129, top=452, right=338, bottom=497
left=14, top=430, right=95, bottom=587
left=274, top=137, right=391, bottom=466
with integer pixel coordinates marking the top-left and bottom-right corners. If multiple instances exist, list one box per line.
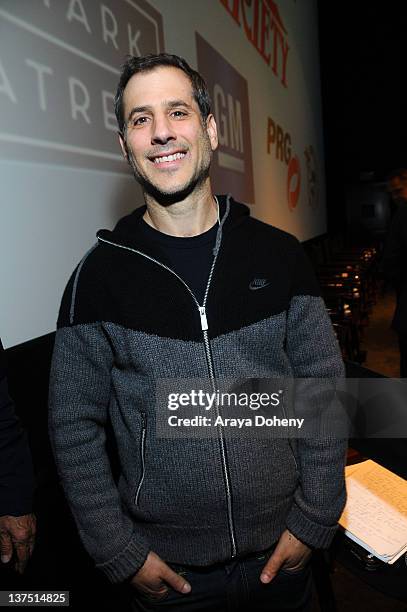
left=49, top=250, right=149, bottom=582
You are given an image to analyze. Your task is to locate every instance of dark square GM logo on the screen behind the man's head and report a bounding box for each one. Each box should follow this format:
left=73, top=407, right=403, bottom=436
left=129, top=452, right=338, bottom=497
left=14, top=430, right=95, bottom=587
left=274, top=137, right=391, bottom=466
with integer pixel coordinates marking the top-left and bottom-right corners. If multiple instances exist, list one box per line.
left=195, top=33, right=254, bottom=204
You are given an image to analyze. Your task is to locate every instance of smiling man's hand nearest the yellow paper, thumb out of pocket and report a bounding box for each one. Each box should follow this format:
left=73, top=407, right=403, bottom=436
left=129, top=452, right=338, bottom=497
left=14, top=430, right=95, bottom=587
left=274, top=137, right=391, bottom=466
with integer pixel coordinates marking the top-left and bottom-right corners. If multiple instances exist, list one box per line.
left=260, top=529, right=311, bottom=584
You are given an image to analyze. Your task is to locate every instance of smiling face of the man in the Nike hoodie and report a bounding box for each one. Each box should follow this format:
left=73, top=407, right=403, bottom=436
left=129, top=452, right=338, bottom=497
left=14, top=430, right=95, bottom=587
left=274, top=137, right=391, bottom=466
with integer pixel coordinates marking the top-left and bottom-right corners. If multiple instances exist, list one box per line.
left=120, top=66, right=218, bottom=200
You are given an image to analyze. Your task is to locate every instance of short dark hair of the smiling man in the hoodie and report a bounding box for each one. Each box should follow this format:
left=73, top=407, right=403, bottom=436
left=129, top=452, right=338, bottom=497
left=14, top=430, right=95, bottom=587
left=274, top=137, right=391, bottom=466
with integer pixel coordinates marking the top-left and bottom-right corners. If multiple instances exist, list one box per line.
left=114, top=53, right=211, bottom=134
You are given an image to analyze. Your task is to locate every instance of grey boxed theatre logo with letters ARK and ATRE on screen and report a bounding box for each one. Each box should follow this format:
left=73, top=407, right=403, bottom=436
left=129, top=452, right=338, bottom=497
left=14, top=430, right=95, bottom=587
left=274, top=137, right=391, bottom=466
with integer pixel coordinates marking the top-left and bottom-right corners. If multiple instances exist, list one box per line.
left=0, top=0, right=164, bottom=174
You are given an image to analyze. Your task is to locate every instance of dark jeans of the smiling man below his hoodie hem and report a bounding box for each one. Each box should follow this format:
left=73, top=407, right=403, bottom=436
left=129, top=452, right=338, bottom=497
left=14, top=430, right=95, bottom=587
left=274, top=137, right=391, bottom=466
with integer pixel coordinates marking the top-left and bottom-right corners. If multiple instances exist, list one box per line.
left=131, top=551, right=312, bottom=612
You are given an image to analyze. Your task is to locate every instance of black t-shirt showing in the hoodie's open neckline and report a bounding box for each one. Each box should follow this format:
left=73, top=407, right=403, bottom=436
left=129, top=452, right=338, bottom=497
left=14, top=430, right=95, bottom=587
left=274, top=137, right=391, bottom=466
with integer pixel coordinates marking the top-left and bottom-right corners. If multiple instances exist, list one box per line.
left=142, top=220, right=219, bottom=305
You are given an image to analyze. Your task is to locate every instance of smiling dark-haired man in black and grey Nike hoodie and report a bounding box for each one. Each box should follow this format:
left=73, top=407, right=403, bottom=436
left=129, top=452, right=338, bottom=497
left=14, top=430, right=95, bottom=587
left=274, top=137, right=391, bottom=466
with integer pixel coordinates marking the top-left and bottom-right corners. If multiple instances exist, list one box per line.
left=50, top=54, right=345, bottom=611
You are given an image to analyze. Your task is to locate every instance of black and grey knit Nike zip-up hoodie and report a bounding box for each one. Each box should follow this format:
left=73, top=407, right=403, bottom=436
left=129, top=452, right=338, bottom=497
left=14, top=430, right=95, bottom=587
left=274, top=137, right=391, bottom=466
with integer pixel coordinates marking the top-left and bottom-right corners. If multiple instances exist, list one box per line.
left=49, top=196, right=345, bottom=582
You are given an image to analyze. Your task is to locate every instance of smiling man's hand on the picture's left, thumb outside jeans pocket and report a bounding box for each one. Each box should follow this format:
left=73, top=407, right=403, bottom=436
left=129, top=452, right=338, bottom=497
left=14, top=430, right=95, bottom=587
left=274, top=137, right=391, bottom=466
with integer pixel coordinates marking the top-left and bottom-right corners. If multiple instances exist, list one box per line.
left=130, top=551, right=191, bottom=599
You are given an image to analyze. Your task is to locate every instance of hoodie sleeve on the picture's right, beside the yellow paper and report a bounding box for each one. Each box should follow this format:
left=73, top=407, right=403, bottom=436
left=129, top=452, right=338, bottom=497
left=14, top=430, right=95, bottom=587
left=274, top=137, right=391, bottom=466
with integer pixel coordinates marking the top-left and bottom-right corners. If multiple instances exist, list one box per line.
left=287, top=237, right=347, bottom=548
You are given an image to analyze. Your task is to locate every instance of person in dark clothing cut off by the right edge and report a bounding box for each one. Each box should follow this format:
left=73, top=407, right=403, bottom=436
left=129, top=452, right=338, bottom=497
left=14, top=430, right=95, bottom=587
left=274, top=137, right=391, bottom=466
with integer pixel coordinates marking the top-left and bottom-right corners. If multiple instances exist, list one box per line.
left=383, top=169, right=407, bottom=378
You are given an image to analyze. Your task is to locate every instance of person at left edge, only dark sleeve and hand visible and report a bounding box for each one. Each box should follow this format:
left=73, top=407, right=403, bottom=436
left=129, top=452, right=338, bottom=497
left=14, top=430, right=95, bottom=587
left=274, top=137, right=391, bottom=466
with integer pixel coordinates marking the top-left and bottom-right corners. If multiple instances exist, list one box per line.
left=0, top=340, right=35, bottom=574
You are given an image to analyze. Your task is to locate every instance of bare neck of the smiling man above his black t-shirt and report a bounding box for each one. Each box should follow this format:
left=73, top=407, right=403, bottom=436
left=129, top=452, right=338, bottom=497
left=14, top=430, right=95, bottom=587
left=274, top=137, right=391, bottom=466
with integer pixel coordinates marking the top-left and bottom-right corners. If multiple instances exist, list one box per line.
left=143, top=181, right=218, bottom=237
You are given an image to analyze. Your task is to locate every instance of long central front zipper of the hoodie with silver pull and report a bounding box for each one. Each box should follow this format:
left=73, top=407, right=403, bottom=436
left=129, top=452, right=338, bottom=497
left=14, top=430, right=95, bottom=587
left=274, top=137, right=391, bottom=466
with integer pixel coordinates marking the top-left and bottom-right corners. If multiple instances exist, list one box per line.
left=98, top=230, right=237, bottom=559
